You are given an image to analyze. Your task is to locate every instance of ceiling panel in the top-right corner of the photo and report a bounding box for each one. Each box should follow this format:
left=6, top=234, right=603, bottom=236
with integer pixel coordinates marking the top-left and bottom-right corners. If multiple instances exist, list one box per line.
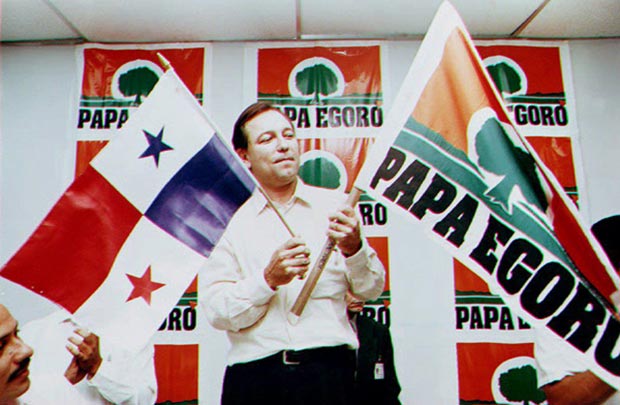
left=521, top=0, right=620, bottom=38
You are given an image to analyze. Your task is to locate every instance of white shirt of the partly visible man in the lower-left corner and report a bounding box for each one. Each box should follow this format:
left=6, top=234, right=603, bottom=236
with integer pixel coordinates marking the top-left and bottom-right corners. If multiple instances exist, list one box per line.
left=20, top=311, right=157, bottom=405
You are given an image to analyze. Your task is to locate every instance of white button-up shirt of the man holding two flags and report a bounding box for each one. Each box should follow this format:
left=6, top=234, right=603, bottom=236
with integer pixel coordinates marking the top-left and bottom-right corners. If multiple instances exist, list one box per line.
left=198, top=180, right=385, bottom=365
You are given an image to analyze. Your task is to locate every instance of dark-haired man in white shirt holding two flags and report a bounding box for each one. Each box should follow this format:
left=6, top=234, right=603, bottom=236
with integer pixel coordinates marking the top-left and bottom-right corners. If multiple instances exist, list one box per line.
left=199, top=103, right=385, bottom=405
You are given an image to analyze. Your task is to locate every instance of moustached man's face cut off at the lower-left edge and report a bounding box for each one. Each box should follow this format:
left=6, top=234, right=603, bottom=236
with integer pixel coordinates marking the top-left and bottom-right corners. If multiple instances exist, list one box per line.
left=0, top=305, right=32, bottom=402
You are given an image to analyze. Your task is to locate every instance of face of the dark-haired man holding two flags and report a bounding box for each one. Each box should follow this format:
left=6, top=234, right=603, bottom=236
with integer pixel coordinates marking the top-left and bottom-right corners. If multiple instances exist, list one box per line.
left=238, top=110, right=299, bottom=188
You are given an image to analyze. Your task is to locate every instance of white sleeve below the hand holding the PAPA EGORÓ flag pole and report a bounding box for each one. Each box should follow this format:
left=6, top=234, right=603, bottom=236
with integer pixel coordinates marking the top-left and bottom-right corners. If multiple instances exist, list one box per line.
left=345, top=238, right=385, bottom=301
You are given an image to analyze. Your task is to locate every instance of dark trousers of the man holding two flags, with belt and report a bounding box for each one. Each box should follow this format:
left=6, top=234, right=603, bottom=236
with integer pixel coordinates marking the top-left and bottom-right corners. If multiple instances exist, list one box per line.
left=222, top=346, right=355, bottom=405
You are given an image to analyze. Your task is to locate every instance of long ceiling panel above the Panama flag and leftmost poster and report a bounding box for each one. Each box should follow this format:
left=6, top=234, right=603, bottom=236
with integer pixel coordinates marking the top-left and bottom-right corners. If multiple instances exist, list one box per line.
left=49, top=0, right=296, bottom=42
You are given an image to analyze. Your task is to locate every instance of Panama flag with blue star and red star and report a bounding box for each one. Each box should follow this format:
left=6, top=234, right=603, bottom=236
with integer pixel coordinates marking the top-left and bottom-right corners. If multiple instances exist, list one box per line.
left=0, top=69, right=255, bottom=350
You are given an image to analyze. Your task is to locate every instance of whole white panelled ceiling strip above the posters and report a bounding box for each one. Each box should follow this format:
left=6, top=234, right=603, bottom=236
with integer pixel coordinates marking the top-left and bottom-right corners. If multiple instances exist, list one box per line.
left=0, top=0, right=620, bottom=43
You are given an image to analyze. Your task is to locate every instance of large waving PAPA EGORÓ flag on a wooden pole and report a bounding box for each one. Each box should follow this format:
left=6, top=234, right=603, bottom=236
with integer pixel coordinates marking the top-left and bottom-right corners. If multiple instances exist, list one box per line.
left=356, top=3, right=620, bottom=388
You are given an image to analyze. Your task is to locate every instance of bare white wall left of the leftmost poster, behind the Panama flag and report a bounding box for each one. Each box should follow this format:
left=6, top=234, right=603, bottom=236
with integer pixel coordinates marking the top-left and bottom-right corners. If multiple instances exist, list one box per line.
left=0, top=46, right=76, bottom=322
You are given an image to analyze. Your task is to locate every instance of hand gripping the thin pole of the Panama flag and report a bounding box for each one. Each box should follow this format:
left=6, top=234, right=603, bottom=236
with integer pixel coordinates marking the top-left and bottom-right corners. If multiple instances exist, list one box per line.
left=264, top=237, right=310, bottom=290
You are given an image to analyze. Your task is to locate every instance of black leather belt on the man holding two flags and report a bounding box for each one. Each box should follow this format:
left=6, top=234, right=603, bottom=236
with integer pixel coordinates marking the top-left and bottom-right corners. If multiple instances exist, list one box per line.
left=237, top=345, right=355, bottom=366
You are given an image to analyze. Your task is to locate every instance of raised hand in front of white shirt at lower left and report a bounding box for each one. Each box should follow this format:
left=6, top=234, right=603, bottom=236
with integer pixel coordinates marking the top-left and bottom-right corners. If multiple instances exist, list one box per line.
left=65, top=329, right=101, bottom=384
